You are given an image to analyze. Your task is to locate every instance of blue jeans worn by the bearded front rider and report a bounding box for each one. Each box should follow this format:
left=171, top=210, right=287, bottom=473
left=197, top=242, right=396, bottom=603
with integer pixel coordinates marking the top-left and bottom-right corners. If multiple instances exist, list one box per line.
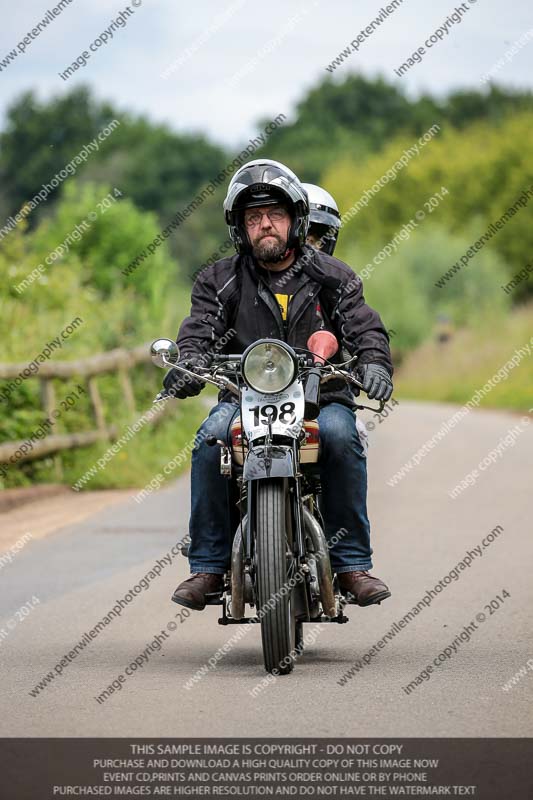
left=189, top=403, right=372, bottom=574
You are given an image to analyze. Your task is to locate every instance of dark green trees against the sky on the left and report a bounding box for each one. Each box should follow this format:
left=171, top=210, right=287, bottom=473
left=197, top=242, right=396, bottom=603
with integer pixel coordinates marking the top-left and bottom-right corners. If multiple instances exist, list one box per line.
left=0, top=88, right=227, bottom=231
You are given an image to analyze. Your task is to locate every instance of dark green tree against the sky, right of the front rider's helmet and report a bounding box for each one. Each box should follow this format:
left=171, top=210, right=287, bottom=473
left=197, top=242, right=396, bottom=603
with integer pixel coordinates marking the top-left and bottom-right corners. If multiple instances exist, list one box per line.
left=263, top=73, right=533, bottom=182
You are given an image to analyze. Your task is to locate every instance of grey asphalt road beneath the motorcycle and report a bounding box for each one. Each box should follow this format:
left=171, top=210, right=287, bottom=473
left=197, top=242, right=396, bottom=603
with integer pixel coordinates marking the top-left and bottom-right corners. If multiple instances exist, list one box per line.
left=0, top=402, right=533, bottom=737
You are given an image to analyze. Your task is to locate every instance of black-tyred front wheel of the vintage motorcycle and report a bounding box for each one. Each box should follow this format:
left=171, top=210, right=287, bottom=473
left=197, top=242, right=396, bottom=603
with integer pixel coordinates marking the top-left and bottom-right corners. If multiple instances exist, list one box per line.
left=255, top=478, right=296, bottom=675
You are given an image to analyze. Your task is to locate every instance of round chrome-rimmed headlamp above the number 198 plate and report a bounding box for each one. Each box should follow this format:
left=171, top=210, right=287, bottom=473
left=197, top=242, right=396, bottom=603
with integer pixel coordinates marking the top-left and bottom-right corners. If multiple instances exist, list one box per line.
left=242, top=339, right=298, bottom=394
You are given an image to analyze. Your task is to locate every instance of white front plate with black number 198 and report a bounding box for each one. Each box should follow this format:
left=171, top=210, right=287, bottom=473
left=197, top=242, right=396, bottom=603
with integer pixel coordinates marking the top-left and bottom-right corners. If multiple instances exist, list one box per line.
left=241, top=380, right=305, bottom=442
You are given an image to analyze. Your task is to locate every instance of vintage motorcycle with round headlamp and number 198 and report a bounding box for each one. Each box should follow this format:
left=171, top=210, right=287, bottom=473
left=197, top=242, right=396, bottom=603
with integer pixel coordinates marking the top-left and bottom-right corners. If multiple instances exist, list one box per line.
left=151, top=331, right=384, bottom=674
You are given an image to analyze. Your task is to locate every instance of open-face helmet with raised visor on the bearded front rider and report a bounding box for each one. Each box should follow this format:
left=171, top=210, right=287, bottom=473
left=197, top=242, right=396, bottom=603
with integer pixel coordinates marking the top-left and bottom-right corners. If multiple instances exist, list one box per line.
left=224, top=158, right=309, bottom=253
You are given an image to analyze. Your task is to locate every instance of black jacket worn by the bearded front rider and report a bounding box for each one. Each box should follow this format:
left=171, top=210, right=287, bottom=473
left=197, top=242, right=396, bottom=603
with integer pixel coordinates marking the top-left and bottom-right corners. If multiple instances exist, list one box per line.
left=177, top=245, right=393, bottom=408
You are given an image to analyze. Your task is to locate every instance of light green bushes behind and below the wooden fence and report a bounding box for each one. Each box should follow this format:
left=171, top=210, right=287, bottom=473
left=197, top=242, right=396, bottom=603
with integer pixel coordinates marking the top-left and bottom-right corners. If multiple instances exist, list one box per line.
left=0, top=182, right=200, bottom=488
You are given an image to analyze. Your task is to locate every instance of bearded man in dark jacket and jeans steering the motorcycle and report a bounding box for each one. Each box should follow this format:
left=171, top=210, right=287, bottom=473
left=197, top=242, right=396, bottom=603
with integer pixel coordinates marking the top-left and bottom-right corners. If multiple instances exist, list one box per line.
left=163, top=159, right=393, bottom=610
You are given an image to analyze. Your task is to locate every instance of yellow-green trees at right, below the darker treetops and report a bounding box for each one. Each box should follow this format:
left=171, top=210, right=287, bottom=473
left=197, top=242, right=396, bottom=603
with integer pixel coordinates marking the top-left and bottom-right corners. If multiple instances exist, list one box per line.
left=323, top=112, right=533, bottom=299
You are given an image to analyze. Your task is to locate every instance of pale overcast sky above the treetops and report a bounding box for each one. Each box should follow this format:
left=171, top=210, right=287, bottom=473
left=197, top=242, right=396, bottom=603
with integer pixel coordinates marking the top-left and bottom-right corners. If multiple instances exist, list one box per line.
left=0, top=0, right=533, bottom=148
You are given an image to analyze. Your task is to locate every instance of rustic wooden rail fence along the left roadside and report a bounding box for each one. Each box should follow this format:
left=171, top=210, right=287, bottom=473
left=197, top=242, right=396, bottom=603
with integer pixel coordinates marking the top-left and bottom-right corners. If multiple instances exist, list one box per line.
left=0, top=344, right=171, bottom=477
